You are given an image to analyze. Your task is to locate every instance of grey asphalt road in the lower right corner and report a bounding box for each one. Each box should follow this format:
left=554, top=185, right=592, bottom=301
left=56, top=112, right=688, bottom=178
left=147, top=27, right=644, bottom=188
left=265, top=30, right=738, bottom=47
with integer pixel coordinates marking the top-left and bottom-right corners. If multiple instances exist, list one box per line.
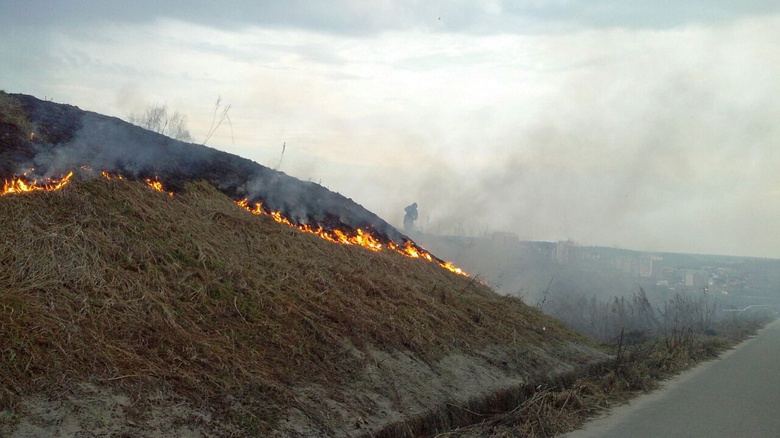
left=566, top=320, right=780, bottom=438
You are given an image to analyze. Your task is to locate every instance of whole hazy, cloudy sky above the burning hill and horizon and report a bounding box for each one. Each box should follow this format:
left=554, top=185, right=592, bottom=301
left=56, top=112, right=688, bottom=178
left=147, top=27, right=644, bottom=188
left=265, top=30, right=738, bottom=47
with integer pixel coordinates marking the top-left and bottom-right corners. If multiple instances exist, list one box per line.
left=0, top=0, right=780, bottom=258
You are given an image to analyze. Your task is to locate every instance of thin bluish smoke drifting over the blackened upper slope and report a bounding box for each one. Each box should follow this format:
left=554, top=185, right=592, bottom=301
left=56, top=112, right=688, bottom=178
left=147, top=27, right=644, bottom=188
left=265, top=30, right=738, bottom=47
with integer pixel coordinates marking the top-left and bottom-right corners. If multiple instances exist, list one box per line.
left=13, top=96, right=408, bottom=244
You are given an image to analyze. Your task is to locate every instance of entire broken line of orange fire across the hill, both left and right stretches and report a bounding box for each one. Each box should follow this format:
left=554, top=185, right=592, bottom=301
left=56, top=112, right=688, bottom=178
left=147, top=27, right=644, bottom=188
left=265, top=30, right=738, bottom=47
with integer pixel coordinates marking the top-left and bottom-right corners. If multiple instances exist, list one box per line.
left=0, top=166, right=469, bottom=277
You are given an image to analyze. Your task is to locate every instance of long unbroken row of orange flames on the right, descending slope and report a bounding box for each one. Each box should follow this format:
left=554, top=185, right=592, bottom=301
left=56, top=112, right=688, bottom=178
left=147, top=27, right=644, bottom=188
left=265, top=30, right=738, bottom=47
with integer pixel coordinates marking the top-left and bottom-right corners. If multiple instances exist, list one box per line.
left=236, top=198, right=470, bottom=277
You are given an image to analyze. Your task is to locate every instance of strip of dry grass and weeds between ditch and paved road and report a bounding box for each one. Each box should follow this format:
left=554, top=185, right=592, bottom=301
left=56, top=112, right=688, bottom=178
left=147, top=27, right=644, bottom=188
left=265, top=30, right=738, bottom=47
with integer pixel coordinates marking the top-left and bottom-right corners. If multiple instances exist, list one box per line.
left=436, top=320, right=766, bottom=438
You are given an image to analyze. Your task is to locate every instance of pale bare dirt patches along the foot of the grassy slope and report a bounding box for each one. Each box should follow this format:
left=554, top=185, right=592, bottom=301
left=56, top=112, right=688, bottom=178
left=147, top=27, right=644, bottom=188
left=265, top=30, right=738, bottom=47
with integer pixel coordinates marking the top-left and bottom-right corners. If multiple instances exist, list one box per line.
left=0, top=344, right=605, bottom=438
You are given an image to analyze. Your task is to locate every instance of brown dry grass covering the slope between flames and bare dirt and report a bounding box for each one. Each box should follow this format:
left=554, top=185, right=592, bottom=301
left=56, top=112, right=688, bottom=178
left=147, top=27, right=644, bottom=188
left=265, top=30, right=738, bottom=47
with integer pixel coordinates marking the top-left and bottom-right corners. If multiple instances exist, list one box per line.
left=0, top=175, right=576, bottom=433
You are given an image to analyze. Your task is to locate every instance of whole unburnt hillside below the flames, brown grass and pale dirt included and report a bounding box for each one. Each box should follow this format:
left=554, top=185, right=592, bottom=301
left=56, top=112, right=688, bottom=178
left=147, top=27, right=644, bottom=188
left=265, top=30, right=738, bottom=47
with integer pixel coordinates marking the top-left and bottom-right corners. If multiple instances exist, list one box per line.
left=0, top=176, right=599, bottom=436
